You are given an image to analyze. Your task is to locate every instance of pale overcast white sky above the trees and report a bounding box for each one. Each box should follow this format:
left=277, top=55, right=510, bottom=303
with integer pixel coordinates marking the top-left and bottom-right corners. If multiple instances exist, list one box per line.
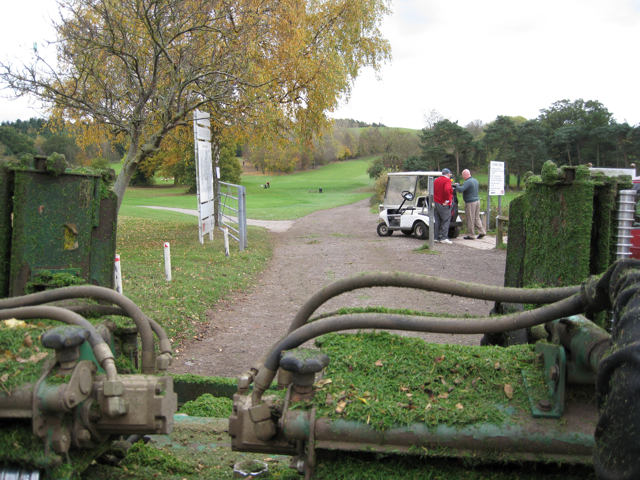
left=0, top=0, right=640, bottom=128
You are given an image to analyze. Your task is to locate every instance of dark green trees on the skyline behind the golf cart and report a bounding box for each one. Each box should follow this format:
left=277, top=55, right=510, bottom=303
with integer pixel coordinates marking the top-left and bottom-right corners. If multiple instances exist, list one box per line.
left=369, top=99, right=640, bottom=186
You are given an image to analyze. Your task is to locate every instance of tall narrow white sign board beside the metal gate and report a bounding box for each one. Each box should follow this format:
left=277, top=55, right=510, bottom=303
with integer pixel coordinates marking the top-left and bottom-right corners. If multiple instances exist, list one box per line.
left=193, top=110, right=215, bottom=243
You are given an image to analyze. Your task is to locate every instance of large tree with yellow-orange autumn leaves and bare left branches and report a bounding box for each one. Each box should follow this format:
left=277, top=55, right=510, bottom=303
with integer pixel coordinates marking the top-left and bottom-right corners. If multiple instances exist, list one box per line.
left=0, top=0, right=390, bottom=212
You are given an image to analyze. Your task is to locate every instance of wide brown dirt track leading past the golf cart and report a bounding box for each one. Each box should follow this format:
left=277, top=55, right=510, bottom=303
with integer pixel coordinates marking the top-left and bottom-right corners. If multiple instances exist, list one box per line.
left=171, top=200, right=506, bottom=377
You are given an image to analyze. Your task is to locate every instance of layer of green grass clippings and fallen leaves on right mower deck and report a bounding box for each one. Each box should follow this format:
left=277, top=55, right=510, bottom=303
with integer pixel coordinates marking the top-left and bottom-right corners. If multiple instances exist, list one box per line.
left=300, top=332, right=548, bottom=430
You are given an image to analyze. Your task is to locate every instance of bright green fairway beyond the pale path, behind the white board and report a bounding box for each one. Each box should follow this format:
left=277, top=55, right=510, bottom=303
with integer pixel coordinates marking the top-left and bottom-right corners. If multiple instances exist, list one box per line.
left=120, top=158, right=373, bottom=220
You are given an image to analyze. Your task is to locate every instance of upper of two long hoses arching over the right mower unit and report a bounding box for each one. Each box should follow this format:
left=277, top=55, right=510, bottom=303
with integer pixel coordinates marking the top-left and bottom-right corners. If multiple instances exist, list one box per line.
left=287, top=272, right=580, bottom=333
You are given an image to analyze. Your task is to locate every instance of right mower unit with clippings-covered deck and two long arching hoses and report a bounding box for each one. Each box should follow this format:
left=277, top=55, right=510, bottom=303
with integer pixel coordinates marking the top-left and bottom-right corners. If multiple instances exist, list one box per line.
left=229, top=167, right=640, bottom=479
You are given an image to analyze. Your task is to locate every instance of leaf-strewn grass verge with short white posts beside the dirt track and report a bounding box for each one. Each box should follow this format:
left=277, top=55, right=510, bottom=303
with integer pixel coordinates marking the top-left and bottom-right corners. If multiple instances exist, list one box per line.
left=117, top=213, right=272, bottom=345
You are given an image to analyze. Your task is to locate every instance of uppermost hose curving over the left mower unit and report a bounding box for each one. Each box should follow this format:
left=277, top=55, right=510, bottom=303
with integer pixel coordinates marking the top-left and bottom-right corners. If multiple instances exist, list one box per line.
left=0, top=285, right=156, bottom=374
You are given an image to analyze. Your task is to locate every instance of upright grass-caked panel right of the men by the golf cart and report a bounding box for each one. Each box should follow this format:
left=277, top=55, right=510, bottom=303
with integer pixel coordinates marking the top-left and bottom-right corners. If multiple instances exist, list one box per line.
left=505, top=161, right=632, bottom=325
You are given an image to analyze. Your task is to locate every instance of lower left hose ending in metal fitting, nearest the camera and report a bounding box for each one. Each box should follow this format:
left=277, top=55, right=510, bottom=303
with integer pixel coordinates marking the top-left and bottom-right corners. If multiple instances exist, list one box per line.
left=0, top=306, right=118, bottom=380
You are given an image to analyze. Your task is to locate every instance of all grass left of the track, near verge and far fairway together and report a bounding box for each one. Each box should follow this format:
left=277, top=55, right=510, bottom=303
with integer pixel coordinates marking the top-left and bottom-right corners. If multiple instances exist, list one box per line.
left=110, top=159, right=373, bottom=346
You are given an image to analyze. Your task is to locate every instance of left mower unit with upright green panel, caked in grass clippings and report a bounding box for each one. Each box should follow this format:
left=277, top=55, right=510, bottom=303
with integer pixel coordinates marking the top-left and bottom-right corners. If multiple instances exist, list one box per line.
left=0, top=154, right=177, bottom=478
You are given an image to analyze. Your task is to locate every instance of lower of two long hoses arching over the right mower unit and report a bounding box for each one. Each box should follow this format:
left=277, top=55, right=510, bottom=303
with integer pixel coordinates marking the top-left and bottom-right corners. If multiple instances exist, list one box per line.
left=264, top=294, right=584, bottom=372
